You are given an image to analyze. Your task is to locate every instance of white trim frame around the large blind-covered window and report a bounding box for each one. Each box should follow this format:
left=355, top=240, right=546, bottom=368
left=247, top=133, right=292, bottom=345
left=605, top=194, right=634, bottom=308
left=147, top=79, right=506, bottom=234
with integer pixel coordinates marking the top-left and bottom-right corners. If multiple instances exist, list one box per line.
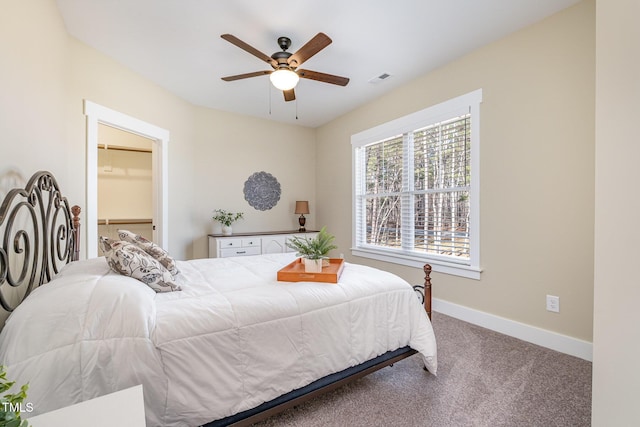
left=351, top=89, right=482, bottom=280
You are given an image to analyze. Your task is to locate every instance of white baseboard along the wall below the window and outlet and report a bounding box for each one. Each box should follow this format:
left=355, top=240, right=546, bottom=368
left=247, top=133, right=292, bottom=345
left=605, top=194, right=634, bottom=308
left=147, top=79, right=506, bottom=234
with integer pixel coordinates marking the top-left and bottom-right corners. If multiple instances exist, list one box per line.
left=432, top=298, right=593, bottom=362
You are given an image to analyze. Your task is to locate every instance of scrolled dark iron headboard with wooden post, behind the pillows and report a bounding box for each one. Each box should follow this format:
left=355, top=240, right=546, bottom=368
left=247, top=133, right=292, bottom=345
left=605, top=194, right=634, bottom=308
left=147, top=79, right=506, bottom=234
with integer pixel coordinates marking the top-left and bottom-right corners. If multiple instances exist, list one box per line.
left=0, top=171, right=80, bottom=311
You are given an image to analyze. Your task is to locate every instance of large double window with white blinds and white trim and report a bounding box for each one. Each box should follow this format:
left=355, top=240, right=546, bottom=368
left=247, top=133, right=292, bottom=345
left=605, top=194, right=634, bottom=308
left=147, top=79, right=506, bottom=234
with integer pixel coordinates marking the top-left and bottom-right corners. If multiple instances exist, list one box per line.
left=351, top=90, right=482, bottom=279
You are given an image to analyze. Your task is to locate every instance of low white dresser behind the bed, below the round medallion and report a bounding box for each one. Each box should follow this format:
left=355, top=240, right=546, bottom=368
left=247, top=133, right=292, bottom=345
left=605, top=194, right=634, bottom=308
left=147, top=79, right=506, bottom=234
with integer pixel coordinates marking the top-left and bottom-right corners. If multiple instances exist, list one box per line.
left=209, top=230, right=318, bottom=258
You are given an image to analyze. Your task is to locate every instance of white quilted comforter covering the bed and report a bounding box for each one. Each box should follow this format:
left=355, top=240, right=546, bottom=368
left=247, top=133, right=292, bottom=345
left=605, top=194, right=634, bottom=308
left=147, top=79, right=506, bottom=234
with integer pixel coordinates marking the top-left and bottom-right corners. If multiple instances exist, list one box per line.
left=0, top=254, right=437, bottom=427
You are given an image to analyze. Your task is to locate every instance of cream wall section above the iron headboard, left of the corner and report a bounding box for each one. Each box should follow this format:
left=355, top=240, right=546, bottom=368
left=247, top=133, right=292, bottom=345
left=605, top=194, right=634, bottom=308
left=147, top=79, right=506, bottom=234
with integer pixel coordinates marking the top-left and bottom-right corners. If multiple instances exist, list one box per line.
left=0, top=0, right=70, bottom=186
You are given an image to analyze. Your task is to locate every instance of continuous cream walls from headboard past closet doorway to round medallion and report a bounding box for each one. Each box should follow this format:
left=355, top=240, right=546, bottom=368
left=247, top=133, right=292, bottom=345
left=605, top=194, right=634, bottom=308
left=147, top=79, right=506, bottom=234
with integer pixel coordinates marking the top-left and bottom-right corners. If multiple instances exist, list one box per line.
left=0, top=0, right=315, bottom=258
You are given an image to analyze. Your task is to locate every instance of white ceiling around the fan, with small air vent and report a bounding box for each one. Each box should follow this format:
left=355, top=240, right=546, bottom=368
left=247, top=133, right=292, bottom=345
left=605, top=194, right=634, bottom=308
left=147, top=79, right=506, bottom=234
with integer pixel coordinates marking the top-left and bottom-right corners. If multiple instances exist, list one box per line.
left=57, top=0, right=579, bottom=127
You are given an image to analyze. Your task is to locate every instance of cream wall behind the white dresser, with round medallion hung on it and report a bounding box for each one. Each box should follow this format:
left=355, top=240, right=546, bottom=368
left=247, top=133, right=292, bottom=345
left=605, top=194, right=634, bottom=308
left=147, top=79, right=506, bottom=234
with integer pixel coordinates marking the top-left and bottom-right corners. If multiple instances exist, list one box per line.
left=190, top=108, right=316, bottom=256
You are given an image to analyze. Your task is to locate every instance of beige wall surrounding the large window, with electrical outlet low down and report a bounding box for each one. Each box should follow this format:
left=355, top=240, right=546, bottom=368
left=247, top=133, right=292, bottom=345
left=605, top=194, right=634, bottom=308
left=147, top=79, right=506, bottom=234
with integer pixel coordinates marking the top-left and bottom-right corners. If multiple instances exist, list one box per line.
left=317, top=1, right=595, bottom=341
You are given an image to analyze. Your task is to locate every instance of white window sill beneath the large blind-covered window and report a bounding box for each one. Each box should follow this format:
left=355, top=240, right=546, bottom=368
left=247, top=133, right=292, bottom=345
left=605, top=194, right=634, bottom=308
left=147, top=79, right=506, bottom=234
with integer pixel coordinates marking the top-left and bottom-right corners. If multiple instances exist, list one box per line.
left=351, top=248, right=482, bottom=280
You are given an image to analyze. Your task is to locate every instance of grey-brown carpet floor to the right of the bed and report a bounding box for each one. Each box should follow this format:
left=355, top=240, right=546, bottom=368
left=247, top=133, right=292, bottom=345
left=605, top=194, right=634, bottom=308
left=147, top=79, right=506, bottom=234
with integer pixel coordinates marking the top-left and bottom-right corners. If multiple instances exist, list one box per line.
left=251, top=313, right=591, bottom=427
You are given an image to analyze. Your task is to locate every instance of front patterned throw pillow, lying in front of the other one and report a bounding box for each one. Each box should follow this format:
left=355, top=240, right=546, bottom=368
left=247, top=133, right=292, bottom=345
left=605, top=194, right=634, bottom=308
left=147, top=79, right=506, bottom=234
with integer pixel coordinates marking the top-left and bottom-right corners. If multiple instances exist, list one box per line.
left=100, top=236, right=182, bottom=292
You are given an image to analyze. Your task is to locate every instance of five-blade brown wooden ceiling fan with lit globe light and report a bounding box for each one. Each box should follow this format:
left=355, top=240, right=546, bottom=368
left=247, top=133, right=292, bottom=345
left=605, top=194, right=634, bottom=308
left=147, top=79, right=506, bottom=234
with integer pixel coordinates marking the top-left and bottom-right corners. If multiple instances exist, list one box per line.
left=220, top=33, right=349, bottom=101
